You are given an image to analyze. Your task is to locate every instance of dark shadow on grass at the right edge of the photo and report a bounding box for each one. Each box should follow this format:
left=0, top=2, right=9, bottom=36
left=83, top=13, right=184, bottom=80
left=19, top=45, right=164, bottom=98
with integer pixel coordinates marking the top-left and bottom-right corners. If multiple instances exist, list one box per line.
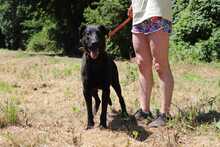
left=196, top=110, right=220, bottom=124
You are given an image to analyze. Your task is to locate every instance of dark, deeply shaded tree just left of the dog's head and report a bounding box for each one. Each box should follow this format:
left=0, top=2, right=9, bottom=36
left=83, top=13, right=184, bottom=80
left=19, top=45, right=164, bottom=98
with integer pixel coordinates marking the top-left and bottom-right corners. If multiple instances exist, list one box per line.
left=38, top=0, right=98, bottom=56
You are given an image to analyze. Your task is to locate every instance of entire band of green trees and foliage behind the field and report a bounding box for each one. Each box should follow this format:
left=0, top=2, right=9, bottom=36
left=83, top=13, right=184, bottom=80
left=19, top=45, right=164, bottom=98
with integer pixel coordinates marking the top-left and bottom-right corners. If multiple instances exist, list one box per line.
left=0, top=0, right=220, bottom=62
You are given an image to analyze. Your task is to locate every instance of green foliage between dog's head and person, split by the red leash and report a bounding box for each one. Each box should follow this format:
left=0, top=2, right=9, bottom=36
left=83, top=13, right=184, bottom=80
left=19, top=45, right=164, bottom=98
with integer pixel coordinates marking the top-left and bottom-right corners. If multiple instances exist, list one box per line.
left=84, top=0, right=132, bottom=58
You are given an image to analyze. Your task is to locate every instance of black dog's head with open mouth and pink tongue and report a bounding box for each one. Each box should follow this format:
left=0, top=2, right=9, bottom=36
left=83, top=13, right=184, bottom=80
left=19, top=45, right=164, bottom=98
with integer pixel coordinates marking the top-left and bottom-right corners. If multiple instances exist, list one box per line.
left=80, top=25, right=108, bottom=59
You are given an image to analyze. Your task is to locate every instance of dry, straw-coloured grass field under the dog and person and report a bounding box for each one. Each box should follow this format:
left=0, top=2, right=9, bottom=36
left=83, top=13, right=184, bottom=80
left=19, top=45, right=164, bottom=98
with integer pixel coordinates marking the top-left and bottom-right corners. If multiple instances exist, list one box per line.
left=0, top=50, right=220, bottom=147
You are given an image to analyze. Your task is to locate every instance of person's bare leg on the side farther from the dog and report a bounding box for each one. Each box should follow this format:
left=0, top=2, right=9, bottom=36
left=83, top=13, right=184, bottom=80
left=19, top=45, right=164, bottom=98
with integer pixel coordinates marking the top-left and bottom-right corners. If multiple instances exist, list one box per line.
left=148, top=30, right=174, bottom=113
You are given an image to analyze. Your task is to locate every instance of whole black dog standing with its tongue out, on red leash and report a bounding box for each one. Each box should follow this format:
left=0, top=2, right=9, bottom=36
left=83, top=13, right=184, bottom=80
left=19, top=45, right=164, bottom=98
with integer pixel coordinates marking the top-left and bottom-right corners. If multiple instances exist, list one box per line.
left=80, top=25, right=128, bottom=129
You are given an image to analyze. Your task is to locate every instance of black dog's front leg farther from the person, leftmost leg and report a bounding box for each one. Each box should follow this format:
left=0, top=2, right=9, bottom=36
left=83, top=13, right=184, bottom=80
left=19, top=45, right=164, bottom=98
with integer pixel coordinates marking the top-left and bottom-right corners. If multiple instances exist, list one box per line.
left=83, top=89, right=94, bottom=129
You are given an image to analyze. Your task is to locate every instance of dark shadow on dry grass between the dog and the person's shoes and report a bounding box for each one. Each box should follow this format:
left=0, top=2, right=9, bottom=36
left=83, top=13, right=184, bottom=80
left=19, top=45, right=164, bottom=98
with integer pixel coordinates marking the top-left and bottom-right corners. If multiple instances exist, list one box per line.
left=109, top=110, right=152, bottom=142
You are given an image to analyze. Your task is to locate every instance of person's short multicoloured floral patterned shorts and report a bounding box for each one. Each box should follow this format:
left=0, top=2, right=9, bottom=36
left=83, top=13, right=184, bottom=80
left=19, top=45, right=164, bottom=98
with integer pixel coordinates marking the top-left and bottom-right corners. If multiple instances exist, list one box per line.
left=131, top=16, right=172, bottom=35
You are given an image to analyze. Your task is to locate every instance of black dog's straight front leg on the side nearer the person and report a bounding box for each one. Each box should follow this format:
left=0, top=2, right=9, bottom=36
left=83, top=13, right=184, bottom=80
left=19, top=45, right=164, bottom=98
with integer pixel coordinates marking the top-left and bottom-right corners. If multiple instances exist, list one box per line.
left=100, top=88, right=110, bottom=128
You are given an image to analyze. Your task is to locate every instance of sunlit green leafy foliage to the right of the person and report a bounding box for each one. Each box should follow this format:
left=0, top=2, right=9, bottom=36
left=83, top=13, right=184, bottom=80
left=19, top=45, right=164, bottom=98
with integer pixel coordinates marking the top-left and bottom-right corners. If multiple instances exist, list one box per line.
left=170, top=0, right=220, bottom=62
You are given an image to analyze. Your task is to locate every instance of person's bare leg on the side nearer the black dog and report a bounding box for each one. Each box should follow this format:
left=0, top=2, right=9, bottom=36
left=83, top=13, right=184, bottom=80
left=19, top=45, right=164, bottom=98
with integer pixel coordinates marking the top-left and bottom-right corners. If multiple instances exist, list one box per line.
left=132, top=33, right=153, bottom=112
